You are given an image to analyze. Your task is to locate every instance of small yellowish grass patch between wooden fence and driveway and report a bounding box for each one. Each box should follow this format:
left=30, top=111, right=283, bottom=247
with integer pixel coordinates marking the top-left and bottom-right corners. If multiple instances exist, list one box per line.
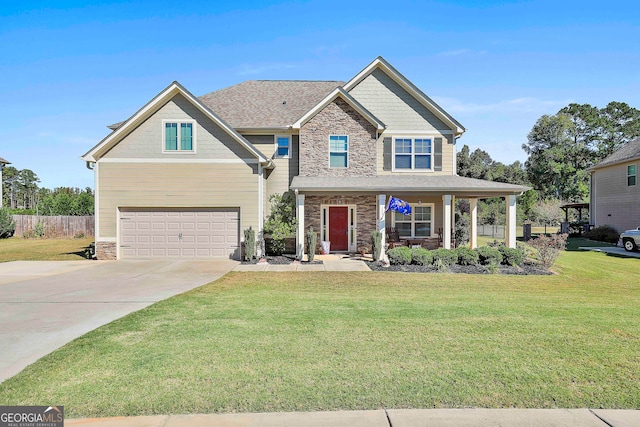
left=0, top=237, right=93, bottom=262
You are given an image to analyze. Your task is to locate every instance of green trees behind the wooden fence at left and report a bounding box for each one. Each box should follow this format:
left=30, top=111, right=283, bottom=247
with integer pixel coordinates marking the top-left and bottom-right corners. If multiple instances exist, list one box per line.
left=2, top=166, right=94, bottom=216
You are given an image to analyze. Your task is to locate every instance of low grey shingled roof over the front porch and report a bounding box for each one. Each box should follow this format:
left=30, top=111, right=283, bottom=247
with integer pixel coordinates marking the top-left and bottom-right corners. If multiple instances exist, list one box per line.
left=291, top=175, right=530, bottom=198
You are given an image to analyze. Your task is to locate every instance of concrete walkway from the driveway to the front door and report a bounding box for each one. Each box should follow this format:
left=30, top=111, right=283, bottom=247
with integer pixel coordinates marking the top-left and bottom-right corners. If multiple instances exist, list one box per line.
left=233, top=254, right=371, bottom=271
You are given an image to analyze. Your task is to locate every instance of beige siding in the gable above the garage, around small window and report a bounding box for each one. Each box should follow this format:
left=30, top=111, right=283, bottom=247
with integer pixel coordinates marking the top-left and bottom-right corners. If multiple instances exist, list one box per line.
left=103, top=95, right=255, bottom=159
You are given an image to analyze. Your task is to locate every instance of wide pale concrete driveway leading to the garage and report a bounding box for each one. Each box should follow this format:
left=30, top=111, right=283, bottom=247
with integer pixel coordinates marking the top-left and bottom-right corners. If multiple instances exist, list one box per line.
left=0, top=260, right=238, bottom=382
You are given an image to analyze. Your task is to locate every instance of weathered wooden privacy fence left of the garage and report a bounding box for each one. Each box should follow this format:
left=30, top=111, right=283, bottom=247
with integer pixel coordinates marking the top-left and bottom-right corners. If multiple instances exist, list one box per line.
left=13, top=215, right=95, bottom=237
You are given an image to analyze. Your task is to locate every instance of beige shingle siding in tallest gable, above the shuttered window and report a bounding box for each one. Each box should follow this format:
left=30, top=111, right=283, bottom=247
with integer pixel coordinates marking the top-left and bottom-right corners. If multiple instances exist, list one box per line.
left=349, top=69, right=451, bottom=131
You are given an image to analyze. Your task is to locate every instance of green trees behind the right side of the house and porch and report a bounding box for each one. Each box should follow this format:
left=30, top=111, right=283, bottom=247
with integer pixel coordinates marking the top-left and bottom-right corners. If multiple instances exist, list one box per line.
left=457, top=101, right=640, bottom=224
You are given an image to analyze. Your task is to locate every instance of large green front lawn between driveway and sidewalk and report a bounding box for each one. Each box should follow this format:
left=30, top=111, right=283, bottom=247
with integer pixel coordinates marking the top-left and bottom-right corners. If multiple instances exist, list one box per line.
left=0, top=252, right=640, bottom=417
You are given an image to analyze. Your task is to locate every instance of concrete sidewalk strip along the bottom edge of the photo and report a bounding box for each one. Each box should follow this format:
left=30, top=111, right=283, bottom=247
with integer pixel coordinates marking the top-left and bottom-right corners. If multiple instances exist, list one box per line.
left=65, top=409, right=640, bottom=427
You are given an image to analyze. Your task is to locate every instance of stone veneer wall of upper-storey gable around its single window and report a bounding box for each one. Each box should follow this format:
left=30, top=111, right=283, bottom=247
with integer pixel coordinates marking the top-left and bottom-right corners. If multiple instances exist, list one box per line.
left=300, top=98, right=377, bottom=177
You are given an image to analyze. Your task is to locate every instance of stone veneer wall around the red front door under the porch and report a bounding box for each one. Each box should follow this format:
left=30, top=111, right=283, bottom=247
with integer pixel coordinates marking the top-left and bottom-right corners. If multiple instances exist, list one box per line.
left=304, top=195, right=378, bottom=249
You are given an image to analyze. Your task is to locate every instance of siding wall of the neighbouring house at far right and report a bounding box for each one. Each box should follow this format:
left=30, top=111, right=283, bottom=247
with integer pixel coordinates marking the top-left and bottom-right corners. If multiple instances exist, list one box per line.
left=591, top=160, right=640, bottom=231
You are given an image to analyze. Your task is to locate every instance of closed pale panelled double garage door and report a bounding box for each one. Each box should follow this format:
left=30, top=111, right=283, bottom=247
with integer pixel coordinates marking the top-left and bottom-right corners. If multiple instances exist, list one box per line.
left=120, top=208, right=240, bottom=258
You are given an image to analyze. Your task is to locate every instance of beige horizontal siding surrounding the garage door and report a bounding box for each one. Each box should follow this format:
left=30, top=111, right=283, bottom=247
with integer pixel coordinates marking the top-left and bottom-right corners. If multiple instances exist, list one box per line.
left=97, top=162, right=259, bottom=239
